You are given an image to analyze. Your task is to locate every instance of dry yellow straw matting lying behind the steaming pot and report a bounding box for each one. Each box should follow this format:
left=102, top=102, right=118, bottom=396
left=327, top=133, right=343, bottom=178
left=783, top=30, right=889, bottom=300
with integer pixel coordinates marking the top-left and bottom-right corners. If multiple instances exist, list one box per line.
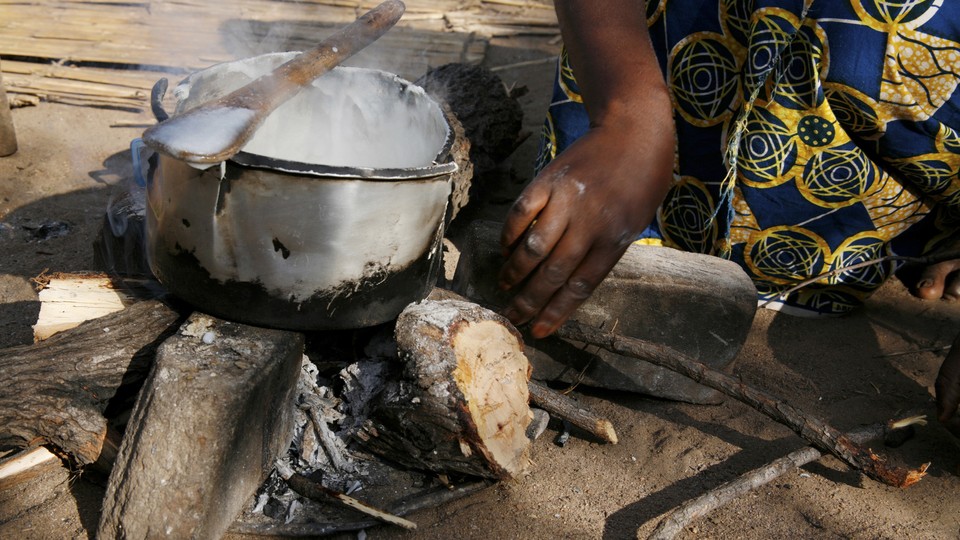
left=0, top=0, right=557, bottom=109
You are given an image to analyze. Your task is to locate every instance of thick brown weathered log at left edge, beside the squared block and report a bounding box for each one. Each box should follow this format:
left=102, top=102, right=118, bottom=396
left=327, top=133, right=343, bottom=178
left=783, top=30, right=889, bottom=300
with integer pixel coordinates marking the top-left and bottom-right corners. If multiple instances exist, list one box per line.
left=0, top=300, right=182, bottom=469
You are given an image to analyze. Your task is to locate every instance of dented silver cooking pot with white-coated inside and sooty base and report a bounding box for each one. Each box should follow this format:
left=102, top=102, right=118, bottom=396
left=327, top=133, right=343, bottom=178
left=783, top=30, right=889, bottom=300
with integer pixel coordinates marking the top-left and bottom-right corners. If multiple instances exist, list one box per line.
left=134, top=53, right=456, bottom=330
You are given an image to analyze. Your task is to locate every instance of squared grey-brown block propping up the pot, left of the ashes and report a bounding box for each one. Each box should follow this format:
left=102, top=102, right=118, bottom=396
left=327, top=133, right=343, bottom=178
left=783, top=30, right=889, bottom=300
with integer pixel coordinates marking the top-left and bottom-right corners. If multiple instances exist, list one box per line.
left=97, top=312, right=303, bottom=539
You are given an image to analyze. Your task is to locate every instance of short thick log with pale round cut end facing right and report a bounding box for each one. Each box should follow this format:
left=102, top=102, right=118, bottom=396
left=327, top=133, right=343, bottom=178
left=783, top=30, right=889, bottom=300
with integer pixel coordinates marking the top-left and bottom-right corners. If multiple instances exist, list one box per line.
left=357, top=300, right=532, bottom=479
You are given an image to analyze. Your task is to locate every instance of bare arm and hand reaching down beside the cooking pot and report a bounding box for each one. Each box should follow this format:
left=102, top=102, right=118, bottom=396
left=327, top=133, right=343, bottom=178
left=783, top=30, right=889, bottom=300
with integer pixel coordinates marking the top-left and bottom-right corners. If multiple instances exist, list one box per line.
left=500, top=0, right=676, bottom=338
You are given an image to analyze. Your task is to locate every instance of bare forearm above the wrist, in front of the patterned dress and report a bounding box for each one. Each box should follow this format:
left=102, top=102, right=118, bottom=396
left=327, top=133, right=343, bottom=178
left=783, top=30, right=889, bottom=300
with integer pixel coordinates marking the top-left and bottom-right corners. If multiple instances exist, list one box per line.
left=555, top=0, right=672, bottom=129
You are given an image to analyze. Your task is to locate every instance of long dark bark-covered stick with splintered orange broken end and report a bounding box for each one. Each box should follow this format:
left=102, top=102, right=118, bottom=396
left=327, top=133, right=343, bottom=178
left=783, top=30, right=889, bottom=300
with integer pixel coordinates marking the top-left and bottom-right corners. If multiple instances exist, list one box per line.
left=556, top=321, right=929, bottom=487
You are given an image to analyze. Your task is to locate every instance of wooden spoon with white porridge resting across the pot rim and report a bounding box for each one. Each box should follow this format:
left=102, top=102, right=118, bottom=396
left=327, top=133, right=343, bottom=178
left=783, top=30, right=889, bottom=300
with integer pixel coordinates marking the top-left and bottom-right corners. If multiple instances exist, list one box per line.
left=143, top=0, right=405, bottom=164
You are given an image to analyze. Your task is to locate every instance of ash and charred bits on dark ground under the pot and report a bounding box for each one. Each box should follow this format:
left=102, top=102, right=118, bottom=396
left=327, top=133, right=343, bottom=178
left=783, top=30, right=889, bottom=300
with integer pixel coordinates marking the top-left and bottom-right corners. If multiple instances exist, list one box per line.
left=231, top=327, right=492, bottom=536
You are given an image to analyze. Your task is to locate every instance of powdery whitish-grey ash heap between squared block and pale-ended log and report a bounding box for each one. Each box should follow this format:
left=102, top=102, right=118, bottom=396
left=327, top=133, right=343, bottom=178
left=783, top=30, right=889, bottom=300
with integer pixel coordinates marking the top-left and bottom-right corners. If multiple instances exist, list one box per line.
left=240, top=334, right=456, bottom=530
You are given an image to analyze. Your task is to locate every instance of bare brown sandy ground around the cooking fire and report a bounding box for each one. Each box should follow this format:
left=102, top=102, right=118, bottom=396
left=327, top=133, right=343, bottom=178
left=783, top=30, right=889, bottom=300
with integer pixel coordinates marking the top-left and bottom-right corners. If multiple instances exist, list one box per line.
left=0, top=35, right=960, bottom=539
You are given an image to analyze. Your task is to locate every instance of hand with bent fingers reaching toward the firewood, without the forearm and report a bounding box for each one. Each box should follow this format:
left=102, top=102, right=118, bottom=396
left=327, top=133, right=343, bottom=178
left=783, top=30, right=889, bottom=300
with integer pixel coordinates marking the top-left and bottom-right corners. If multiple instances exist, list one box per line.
left=500, top=117, right=675, bottom=338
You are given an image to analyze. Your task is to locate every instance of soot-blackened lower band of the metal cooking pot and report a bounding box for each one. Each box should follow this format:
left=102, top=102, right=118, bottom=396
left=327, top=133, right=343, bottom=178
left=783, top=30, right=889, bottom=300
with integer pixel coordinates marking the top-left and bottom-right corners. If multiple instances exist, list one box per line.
left=150, top=250, right=440, bottom=331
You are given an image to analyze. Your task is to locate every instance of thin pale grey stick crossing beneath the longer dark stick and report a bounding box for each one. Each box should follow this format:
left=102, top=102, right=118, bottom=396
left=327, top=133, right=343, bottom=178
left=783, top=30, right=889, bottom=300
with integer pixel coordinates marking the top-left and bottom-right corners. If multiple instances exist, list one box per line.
left=647, top=418, right=928, bottom=540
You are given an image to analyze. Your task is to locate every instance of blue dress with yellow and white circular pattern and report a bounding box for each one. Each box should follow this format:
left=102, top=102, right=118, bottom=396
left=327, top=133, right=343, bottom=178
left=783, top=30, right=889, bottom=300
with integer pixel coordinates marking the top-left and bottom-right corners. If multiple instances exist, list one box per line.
left=537, top=0, right=960, bottom=313
